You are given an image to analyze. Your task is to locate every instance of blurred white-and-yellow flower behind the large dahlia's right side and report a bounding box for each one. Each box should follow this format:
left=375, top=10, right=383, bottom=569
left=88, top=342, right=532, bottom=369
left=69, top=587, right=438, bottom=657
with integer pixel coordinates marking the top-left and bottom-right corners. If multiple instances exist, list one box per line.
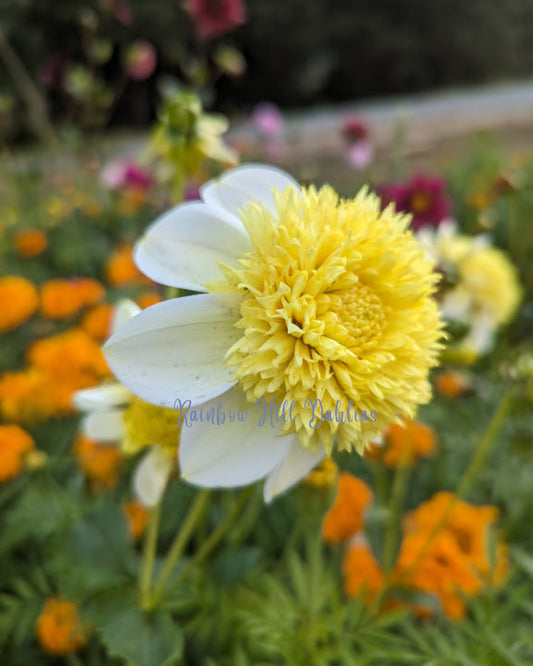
left=417, top=221, right=521, bottom=360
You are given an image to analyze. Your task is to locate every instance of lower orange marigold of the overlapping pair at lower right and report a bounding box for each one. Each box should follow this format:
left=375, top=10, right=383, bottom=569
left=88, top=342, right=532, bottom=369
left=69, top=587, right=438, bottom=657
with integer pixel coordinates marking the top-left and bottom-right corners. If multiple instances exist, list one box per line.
left=394, top=531, right=482, bottom=620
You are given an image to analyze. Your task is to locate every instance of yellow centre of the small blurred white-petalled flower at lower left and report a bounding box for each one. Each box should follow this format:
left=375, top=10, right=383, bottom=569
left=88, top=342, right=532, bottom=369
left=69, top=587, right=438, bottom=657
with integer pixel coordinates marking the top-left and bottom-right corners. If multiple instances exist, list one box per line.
left=122, top=397, right=180, bottom=454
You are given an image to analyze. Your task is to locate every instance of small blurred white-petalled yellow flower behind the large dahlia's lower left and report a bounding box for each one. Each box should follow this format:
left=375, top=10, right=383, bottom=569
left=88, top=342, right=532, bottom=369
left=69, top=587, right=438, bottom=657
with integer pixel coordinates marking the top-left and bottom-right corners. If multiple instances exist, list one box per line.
left=73, top=300, right=179, bottom=507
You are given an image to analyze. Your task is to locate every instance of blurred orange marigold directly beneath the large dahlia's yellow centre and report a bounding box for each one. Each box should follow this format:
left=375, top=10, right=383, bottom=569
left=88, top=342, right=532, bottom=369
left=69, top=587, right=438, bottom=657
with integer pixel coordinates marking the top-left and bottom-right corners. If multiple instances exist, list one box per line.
left=322, top=472, right=373, bottom=543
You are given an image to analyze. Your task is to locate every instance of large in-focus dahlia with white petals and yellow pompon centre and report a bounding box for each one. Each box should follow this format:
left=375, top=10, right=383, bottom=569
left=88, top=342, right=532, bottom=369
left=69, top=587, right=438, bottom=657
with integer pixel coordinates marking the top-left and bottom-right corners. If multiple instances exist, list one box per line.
left=104, top=166, right=441, bottom=500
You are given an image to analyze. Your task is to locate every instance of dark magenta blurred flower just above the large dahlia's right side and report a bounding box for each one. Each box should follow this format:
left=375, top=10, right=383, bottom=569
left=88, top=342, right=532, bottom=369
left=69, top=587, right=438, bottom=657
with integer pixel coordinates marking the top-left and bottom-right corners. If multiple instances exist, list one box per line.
left=378, top=174, right=451, bottom=231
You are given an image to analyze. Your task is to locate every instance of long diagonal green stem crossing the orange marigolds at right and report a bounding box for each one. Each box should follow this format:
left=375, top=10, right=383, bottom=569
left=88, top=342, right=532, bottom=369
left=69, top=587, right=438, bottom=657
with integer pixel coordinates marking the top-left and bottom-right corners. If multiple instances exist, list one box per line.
left=401, top=389, right=512, bottom=578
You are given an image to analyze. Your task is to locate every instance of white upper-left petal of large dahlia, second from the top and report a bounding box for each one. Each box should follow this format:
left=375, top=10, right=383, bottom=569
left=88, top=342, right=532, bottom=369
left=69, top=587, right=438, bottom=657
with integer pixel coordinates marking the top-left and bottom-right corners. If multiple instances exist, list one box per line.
left=134, top=202, right=252, bottom=291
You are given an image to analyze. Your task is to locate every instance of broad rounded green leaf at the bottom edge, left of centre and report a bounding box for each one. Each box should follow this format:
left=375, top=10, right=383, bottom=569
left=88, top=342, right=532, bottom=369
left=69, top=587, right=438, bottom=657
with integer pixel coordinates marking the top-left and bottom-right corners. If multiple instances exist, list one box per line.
left=99, top=608, right=183, bottom=666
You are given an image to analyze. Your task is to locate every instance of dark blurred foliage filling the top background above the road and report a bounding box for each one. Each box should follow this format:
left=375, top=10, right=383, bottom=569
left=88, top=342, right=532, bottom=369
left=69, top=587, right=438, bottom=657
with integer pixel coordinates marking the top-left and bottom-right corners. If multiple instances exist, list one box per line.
left=0, top=0, right=533, bottom=132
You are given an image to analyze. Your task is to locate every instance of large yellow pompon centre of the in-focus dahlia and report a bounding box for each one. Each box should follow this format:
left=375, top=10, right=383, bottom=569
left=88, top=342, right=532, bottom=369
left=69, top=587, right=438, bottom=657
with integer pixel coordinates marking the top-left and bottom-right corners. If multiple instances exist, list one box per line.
left=209, top=187, right=441, bottom=454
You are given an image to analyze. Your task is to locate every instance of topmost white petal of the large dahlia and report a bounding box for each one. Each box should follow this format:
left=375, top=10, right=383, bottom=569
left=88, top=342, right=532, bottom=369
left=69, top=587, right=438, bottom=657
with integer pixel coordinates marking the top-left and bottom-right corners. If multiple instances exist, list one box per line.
left=200, top=164, right=300, bottom=228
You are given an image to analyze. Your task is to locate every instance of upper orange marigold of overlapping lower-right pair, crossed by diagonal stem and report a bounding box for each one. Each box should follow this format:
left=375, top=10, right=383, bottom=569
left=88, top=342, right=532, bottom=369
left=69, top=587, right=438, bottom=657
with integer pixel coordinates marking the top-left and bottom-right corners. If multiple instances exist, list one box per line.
left=404, top=492, right=507, bottom=580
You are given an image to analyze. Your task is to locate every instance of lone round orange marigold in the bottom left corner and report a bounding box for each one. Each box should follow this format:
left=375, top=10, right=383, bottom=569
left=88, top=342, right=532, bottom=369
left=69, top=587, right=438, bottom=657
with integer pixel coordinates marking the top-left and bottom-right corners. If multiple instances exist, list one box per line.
left=35, top=598, right=88, bottom=657
